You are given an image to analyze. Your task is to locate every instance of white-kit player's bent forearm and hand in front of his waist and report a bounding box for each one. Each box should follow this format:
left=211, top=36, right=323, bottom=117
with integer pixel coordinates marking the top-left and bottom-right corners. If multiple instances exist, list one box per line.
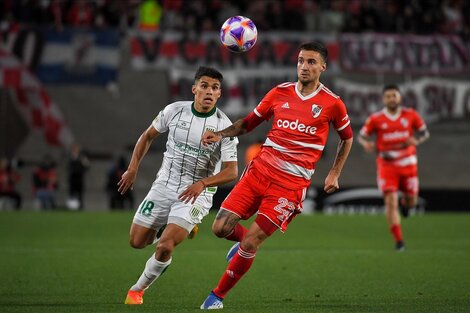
left=178, top=161, right=238, bottom=203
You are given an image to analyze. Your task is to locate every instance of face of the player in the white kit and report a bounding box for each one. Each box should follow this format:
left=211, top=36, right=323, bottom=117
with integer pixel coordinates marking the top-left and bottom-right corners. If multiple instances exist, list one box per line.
left=192, top=76, right=222, bottom=113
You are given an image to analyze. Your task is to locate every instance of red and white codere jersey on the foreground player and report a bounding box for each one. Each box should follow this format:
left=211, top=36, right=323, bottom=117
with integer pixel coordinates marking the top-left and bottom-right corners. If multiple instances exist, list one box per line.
left=253, top=82, right=350, bottom=189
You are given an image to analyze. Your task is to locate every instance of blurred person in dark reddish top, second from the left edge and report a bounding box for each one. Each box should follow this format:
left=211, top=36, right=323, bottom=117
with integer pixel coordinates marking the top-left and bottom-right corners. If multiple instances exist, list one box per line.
left=33, top=155, right=59, bottom=209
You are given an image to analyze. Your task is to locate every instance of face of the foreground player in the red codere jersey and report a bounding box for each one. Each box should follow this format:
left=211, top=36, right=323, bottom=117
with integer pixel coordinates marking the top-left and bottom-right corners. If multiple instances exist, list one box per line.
left=297, top=50, right=326, bottom=85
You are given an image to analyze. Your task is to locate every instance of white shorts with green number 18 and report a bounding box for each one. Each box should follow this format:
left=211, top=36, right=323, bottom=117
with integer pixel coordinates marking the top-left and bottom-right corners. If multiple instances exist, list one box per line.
left=133, top=182, right=213, bottom=232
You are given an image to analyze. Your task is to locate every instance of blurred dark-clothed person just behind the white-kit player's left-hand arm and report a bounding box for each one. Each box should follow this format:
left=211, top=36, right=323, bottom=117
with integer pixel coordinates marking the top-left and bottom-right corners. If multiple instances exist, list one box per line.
left=106, top=156, right=134, bottom=209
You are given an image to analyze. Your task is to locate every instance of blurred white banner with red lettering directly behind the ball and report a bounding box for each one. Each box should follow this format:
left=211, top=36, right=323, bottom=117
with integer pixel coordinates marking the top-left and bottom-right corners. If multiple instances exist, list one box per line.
left=129, top=31, right=339, bottom=74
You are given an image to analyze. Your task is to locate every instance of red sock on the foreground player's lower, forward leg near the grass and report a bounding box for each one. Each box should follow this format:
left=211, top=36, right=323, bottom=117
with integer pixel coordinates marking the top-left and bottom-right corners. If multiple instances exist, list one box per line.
left=213, top=248, right=256, bottom=299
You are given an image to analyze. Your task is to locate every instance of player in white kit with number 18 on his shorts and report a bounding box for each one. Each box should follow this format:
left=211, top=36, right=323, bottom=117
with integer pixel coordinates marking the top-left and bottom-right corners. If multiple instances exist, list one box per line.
left=118, top=67, right=238, bottom=304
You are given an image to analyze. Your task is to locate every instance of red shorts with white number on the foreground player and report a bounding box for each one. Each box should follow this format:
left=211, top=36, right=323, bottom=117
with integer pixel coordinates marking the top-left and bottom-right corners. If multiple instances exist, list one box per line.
left=221, top=167, right=307, bottom=235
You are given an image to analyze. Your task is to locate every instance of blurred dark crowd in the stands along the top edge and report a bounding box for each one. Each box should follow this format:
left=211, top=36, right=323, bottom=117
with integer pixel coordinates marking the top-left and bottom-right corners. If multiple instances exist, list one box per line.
left=0, top=0, right=470, bottom=38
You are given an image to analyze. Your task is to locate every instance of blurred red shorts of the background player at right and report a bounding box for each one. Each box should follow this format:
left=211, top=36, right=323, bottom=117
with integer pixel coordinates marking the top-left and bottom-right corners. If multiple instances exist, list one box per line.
left=377, top=164, right=419, bottom=195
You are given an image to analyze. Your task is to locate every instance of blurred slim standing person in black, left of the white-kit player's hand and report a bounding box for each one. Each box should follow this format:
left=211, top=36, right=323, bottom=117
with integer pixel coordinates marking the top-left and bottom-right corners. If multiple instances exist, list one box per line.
left=67, top=144, right=90, bottom=209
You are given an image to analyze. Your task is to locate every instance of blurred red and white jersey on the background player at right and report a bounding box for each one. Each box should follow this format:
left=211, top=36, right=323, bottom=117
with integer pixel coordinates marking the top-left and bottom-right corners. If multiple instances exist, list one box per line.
left=361, top=108, right=426, bottom=166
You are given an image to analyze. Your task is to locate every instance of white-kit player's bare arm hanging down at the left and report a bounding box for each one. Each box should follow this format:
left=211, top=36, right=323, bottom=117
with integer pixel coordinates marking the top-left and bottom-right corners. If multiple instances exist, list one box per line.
left=118, top=125, right=160, bottom=194
